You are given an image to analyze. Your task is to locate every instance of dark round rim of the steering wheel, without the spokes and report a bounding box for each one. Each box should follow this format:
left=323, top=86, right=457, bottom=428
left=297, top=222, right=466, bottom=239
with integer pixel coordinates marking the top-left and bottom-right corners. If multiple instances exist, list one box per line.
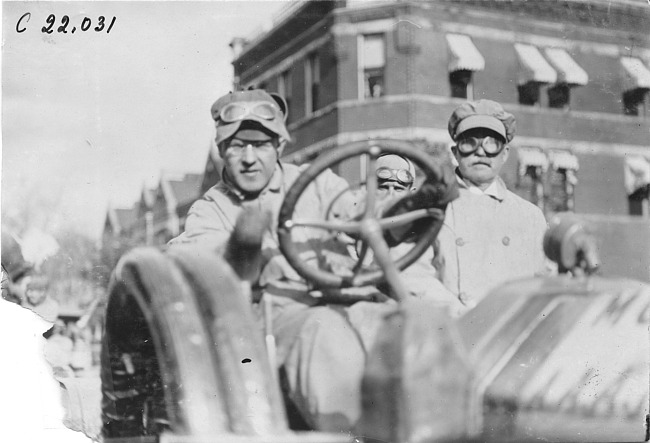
left=278, top=139, right=443, bottom=289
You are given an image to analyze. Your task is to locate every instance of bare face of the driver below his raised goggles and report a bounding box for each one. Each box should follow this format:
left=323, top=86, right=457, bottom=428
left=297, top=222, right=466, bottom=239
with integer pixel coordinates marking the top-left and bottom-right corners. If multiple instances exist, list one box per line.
left=219, top=131, right=281, bottom=197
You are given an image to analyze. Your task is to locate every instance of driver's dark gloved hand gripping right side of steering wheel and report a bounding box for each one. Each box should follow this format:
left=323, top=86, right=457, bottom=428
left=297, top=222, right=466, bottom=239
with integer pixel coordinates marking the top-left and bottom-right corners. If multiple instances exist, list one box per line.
left=383, top=164, right=458, bottom=247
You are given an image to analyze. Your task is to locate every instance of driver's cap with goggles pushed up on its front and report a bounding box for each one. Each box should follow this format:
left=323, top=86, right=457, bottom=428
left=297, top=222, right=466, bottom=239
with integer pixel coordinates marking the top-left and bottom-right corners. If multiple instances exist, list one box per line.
left=210, top=89, right=291, bottom=145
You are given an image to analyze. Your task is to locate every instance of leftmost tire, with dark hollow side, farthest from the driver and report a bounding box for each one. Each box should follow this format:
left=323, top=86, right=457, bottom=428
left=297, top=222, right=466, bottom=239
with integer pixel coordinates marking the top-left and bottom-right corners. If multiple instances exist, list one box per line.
left=101, top=249, right=228, bottom=438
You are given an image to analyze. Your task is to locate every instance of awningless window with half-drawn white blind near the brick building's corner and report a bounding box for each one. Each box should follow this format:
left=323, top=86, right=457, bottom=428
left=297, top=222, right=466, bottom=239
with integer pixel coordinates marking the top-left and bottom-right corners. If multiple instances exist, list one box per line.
left=359, top=34, right=386, bottom=99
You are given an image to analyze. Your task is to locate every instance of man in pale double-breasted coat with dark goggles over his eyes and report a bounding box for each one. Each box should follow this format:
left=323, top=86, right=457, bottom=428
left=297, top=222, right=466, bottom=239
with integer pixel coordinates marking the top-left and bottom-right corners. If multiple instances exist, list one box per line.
left=436, top=100, right=547, bottom=316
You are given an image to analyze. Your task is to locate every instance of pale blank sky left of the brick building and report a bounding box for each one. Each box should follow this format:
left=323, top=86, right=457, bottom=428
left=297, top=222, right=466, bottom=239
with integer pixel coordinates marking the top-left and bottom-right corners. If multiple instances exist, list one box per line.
left=2, top=0, right=289, bottom=239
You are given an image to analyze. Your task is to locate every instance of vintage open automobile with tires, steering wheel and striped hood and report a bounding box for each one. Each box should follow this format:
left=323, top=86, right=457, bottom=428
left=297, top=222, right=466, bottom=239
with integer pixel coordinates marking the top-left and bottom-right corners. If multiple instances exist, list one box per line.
left=102, top=140, right=650, bottom=443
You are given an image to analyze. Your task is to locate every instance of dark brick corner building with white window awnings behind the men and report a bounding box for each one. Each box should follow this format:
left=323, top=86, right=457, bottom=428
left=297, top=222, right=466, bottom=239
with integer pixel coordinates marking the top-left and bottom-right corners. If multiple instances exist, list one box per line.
left=231, top=0, right=650, bottom=217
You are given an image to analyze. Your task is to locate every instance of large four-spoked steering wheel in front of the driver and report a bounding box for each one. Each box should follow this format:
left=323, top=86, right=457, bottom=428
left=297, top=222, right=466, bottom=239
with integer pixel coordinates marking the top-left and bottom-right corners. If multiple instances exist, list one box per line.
left=278, top=139, right=444, bottom=298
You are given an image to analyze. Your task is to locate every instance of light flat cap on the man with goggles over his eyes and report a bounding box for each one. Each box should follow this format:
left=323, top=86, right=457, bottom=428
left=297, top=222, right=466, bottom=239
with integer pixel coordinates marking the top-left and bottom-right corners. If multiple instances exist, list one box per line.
left=448, top=99, right=517, bottom=143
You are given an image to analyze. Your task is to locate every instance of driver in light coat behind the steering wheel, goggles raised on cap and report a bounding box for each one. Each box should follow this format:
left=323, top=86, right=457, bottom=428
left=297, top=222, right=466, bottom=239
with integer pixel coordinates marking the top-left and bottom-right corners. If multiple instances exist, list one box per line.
left=170, top=90, right=456, bottom=432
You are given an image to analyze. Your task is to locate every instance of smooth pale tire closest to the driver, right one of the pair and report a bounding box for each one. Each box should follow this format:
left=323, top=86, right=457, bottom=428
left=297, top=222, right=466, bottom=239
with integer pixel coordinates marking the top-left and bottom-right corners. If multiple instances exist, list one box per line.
left=169, top=247, right=288, bottom=436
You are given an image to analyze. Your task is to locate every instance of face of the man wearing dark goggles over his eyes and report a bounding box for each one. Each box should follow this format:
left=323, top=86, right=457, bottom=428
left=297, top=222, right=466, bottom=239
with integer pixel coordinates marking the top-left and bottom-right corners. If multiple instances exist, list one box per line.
left=452, top=128, right=510, bottom=190
